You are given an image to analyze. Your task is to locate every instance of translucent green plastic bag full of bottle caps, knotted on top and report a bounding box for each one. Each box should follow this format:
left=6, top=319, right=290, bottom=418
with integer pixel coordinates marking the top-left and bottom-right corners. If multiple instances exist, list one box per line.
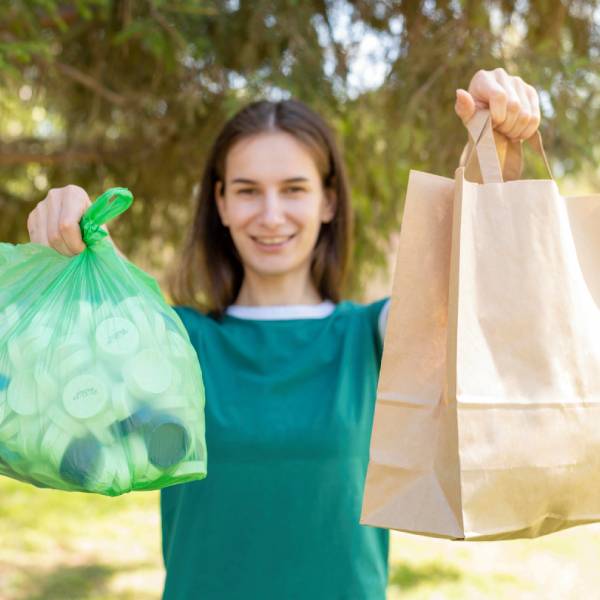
left=0, top=188, right=206, bottom=496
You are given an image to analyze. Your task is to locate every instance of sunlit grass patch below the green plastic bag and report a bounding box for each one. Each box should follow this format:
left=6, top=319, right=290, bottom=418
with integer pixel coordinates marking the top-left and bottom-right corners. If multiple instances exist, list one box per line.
left=0, top=477, right=164, bottom=600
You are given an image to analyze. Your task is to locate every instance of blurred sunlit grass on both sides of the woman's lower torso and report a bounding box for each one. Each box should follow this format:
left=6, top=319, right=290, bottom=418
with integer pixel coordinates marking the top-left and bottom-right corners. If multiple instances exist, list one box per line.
left=0, top=477, right=600, bottom=600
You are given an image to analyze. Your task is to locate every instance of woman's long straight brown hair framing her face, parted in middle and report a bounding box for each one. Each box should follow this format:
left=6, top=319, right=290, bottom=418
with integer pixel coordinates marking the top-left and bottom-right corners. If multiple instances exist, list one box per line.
left=169, top=100, right=352, bottom=317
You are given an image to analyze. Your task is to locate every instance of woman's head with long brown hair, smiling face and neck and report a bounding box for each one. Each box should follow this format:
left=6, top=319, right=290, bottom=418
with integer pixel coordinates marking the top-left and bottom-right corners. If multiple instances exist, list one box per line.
left=171, top=100, right=352, bottom=316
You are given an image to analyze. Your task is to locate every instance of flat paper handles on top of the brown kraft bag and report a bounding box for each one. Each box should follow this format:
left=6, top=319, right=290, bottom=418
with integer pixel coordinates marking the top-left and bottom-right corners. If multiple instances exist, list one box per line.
left=461, top=110, right=553, bottom=183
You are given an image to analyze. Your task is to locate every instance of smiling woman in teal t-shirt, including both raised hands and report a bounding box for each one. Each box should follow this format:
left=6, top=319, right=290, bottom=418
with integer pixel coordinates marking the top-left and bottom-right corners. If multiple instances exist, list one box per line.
left=28, top=69, right=539, bottom=600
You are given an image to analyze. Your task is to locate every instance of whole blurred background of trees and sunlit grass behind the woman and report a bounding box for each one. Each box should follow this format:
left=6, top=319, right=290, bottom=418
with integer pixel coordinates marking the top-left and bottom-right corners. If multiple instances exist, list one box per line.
left=0, top=0, right=600, bottom=600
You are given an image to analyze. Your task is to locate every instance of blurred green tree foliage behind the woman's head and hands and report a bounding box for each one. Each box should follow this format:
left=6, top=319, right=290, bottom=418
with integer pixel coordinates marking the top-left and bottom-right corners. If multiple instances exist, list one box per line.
left=0, top=0, right=600, bottom=295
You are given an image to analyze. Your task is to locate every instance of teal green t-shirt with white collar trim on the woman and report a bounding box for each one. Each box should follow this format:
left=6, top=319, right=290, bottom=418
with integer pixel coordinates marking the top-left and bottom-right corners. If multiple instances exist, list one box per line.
left=161, top=299, right=389, bottom=600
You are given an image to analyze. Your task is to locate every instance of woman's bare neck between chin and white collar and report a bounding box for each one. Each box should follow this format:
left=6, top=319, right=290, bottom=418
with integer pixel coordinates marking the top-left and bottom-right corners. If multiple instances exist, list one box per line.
left=234, top=269, right=323, bottom=306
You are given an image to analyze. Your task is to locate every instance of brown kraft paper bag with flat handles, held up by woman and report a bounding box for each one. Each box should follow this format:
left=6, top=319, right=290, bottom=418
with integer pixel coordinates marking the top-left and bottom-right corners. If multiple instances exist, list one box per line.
left=360, top=111, right=600, bottom=540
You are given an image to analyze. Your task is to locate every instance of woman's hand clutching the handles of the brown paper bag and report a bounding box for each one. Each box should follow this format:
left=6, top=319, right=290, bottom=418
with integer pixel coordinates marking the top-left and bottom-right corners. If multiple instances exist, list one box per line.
left=454, top=69, right=540, bottom=140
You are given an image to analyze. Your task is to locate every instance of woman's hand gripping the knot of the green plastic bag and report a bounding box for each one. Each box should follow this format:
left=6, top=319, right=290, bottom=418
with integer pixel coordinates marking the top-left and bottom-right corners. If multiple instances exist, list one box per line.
left=27, top=185, right=91, bottom=256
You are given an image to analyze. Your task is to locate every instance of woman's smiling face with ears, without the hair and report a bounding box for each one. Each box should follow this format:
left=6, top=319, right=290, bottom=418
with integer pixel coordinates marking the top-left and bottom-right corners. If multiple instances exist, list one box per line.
left=215, top=132, right=335, bottom=276
